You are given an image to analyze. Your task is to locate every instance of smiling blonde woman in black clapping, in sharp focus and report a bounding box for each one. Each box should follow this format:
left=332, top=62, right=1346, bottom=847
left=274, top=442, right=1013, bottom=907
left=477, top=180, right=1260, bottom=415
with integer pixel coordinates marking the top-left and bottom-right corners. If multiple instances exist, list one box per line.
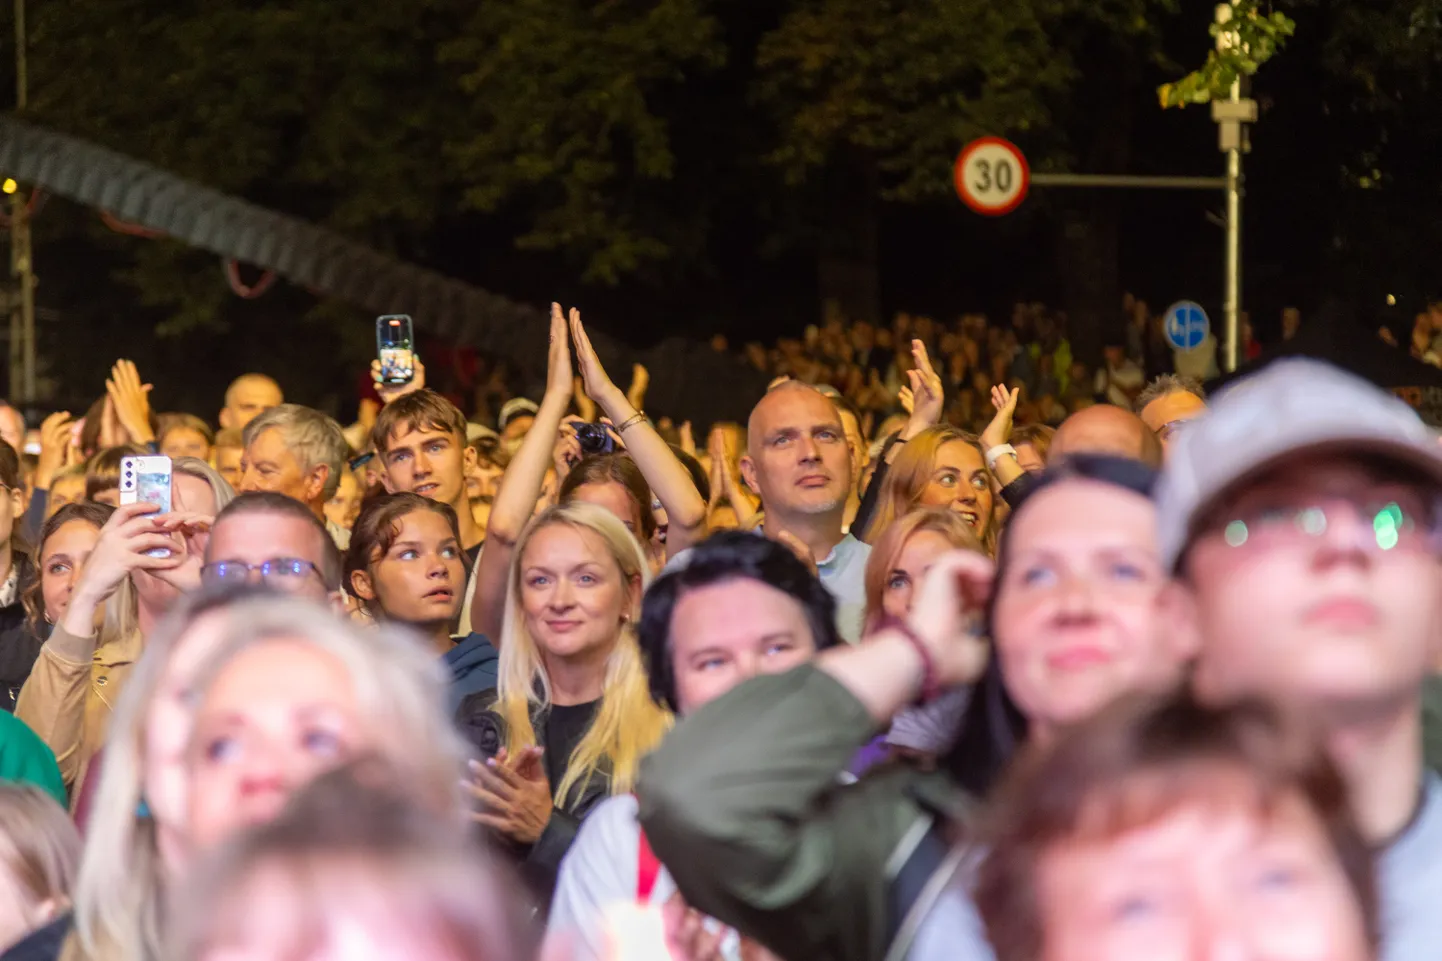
left=457, top=504, right=671, bottom=895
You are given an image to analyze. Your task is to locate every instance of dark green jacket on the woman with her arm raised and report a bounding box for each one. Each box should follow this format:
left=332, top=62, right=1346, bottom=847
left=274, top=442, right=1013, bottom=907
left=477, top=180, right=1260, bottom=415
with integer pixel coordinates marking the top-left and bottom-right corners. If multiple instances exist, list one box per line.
left=637, top=665, right=965, bottom=961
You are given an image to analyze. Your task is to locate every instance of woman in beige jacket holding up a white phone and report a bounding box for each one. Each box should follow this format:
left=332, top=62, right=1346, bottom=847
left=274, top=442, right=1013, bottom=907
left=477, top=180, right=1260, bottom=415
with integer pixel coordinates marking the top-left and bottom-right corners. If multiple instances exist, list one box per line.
left=14, top=457, right=235, bottom=797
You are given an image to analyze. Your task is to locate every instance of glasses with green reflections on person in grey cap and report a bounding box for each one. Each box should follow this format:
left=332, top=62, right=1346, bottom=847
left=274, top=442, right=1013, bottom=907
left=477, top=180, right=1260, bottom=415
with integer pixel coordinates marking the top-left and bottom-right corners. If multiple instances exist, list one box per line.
left=1221, top=491, right=1442, bottom=551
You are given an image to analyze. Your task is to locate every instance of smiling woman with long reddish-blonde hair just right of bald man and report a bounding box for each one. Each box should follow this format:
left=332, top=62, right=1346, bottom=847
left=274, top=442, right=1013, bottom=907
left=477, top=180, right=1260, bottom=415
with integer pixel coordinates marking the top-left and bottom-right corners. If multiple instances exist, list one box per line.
left=867, top=424, right=996, bottom=554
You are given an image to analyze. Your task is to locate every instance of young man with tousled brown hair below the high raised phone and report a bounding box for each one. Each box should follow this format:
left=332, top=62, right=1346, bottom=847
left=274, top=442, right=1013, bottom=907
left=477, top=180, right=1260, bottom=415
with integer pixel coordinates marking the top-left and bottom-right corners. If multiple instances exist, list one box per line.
left=371, top=390, right=486, bottom=635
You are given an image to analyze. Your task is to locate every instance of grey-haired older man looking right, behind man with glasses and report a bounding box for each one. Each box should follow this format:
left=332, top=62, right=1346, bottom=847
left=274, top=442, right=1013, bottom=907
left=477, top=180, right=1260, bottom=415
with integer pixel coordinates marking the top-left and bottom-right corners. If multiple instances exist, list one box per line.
left=236, top=404, right=350, bottom=550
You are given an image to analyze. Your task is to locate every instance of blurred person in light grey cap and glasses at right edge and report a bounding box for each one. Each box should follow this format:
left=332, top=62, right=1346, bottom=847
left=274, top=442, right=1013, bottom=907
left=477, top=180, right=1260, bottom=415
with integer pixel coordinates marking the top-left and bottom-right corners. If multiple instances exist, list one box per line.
left=1156, top=361, right=1442, bottom=961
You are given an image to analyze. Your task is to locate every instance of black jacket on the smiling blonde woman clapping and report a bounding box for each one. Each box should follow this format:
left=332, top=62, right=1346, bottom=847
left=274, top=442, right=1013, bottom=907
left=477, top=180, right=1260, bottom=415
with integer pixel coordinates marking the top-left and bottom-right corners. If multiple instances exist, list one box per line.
left=456, top=688, right=611, bottom=905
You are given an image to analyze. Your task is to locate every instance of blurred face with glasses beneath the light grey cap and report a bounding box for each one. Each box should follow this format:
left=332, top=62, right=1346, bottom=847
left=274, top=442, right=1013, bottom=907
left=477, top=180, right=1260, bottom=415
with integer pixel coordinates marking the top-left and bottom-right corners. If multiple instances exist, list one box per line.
left=1175, top=456, right=1442, bottom=710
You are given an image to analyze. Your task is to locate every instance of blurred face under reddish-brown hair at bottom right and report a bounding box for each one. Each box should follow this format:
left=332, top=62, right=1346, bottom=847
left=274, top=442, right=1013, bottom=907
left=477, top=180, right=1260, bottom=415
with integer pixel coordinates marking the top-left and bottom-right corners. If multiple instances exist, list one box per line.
left=1035, top=795, right=1373, bottom=961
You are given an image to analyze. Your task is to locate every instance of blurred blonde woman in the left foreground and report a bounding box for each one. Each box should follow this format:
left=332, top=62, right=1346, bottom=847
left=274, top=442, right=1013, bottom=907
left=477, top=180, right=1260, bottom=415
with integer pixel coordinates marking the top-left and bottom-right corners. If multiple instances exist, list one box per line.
left=61, top=586, right=464, bottom=961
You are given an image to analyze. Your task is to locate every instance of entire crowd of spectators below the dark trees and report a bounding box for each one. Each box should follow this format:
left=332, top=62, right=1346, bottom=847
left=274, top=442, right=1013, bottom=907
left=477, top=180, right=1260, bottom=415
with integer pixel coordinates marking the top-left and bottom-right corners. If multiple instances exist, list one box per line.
left=0, top=294, right=1424, bottom=961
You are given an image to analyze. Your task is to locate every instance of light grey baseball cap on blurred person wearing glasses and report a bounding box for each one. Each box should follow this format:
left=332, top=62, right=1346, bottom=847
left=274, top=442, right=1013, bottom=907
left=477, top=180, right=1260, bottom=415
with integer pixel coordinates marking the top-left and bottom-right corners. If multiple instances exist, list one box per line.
left=1156, top=358, right=1442, bottom=570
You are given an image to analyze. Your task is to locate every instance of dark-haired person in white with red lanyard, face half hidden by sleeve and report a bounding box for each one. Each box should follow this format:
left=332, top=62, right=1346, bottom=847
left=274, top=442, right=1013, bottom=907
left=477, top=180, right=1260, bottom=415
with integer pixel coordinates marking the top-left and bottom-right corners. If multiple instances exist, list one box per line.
left=548, top=531, right=839, bottom=961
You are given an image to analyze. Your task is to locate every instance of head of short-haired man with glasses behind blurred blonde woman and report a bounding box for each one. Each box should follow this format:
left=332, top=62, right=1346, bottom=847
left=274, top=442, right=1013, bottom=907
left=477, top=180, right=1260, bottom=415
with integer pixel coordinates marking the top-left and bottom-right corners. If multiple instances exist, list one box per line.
left=200, top=492, right=343, bottom=606
